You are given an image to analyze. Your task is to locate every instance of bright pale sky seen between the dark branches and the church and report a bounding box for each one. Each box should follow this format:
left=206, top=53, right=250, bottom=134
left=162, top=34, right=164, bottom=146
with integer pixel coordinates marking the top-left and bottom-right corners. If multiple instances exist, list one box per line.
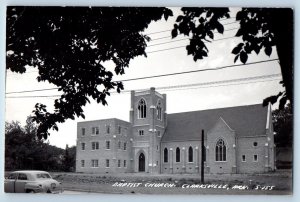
left=5, top=8, right=283, bottom=148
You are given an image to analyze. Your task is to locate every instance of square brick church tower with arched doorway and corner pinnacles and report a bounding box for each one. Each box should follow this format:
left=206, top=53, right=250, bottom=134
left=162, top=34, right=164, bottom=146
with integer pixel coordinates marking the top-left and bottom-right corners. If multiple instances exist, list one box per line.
left=130, top=88, right=167, bottom=173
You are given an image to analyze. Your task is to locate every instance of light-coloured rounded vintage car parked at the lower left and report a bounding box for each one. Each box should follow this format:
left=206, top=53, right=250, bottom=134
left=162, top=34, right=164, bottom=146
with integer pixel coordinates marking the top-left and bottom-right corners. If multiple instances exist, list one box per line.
left=4, top=170, right=63, bottom=193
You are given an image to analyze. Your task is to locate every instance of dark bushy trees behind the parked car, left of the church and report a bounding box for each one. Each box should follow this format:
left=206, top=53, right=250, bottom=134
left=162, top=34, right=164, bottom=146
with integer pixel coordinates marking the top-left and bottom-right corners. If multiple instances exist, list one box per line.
left=5, top=118, right=66, bottom=171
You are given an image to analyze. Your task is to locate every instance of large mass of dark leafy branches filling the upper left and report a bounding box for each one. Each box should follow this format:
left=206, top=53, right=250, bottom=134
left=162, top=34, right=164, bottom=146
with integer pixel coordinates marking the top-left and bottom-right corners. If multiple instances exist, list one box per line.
left=6, top=7, right=172, bottom=139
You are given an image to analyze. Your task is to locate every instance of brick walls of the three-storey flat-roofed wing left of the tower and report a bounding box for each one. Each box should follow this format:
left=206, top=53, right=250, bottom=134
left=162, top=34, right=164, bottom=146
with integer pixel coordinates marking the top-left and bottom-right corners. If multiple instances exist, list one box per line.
left=76, top=119, right=132, bottom=173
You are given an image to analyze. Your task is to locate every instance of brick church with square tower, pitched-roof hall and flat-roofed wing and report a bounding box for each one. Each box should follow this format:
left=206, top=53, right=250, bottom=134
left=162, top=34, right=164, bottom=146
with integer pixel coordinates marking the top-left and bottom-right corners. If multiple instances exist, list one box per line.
left=76, top=88, right=275, bottom=174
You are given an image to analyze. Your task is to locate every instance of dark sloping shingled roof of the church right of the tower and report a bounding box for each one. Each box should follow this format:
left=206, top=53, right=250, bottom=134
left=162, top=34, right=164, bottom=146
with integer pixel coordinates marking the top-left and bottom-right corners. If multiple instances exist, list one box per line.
left=162, top=104, right=268, bottom=142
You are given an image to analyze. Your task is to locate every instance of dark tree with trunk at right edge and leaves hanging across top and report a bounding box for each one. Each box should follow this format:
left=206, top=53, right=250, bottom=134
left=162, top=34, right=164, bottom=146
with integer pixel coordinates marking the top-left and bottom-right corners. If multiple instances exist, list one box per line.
left=171, top=7, right=294, bottom=109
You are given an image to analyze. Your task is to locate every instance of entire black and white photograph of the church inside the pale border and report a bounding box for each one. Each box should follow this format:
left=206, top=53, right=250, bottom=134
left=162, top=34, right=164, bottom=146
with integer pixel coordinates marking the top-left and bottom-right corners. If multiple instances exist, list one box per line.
left=2, top=5, right=294, bottom=195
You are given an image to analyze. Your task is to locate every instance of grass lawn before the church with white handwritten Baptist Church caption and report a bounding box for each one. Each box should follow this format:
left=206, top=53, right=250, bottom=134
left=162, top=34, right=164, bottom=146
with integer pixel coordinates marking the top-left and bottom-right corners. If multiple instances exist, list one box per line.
left=51, top=170, right=292, bottom=195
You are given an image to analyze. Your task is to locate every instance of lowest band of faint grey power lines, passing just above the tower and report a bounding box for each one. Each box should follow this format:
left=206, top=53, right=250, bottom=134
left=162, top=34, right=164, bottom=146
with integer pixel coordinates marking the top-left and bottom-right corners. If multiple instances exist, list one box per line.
left=6, top=74, right=281, bottom=98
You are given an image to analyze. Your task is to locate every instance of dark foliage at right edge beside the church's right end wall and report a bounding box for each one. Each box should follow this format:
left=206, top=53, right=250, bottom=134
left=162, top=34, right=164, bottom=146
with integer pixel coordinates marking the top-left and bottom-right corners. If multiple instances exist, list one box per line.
left=272, top=104, right=293, bottom=147
